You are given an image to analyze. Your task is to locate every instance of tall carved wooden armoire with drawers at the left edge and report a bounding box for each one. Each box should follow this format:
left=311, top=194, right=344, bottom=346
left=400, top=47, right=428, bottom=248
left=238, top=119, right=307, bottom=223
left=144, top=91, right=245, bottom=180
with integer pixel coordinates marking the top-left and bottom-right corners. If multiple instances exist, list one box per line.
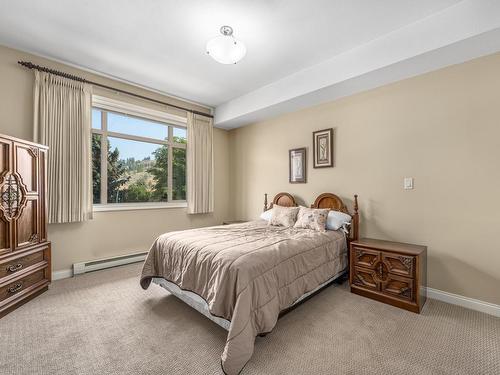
left=0, top=135, right=51, bottom=317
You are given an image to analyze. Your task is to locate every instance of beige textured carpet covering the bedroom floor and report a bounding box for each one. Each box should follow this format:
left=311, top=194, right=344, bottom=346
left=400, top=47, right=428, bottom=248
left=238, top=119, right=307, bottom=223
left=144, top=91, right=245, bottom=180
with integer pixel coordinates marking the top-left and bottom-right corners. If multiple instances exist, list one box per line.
left=0, top=265, right=500, bottom=375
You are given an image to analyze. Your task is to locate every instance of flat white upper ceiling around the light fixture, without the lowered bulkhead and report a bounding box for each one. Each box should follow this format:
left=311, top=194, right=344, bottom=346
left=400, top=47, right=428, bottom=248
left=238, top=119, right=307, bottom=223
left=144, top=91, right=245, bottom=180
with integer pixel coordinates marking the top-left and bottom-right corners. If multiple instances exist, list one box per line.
left=0, top=0, right=497, bottom=127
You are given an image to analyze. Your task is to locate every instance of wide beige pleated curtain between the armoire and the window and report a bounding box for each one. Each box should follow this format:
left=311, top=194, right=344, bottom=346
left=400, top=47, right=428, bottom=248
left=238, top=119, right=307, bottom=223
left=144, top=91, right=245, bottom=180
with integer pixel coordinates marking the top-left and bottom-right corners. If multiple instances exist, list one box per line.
left=34, top=71, right=92, bottom=223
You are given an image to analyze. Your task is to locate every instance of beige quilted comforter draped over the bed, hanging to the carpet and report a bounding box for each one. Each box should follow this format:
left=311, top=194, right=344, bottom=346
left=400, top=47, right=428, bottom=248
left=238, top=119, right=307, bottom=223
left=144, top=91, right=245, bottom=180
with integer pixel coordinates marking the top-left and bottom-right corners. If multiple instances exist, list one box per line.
left=141, top=220, right=347, bottom=375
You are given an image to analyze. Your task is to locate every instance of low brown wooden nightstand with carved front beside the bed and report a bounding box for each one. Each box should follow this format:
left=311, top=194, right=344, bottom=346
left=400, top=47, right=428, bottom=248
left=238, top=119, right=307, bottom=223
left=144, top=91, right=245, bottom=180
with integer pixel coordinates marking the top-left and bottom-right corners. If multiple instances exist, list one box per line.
left=349, top=238, right=427, bottom=313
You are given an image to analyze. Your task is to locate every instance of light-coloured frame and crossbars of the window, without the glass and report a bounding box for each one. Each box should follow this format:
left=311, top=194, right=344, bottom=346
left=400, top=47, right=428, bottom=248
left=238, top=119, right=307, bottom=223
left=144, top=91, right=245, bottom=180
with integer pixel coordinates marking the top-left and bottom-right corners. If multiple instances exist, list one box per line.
left=90, top=95, right=188, bottom=212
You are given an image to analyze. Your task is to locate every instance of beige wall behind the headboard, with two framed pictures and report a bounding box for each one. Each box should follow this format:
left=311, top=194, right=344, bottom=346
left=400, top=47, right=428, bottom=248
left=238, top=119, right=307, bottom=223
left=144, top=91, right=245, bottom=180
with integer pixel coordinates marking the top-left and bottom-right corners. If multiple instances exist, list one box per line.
left=230, top=54, right=500, bottom=304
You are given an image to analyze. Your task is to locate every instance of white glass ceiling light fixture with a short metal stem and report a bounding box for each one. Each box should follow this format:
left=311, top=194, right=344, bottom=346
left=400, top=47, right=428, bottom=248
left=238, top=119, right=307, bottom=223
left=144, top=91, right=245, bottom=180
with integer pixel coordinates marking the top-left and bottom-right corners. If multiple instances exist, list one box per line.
left=207, top=26, right=247, bottom=64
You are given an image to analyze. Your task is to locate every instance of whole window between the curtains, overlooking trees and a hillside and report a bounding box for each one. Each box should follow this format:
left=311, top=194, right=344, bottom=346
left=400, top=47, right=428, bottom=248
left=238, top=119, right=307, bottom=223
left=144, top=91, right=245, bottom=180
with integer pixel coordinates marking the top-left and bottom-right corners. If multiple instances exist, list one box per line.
left=92, top=99, right=187, bottom=207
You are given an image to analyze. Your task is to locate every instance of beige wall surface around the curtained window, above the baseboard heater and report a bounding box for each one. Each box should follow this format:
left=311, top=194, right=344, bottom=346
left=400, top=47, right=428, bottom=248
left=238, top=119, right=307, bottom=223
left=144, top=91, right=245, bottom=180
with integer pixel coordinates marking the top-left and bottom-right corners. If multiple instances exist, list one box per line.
left=0, top=46, right=229, bottom=271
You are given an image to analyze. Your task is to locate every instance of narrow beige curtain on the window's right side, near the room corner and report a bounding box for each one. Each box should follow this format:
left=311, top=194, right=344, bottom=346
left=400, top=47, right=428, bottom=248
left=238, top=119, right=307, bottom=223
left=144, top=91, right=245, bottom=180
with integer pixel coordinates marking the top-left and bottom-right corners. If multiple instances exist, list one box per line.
left=186, top=113, right=214, bottom=214
